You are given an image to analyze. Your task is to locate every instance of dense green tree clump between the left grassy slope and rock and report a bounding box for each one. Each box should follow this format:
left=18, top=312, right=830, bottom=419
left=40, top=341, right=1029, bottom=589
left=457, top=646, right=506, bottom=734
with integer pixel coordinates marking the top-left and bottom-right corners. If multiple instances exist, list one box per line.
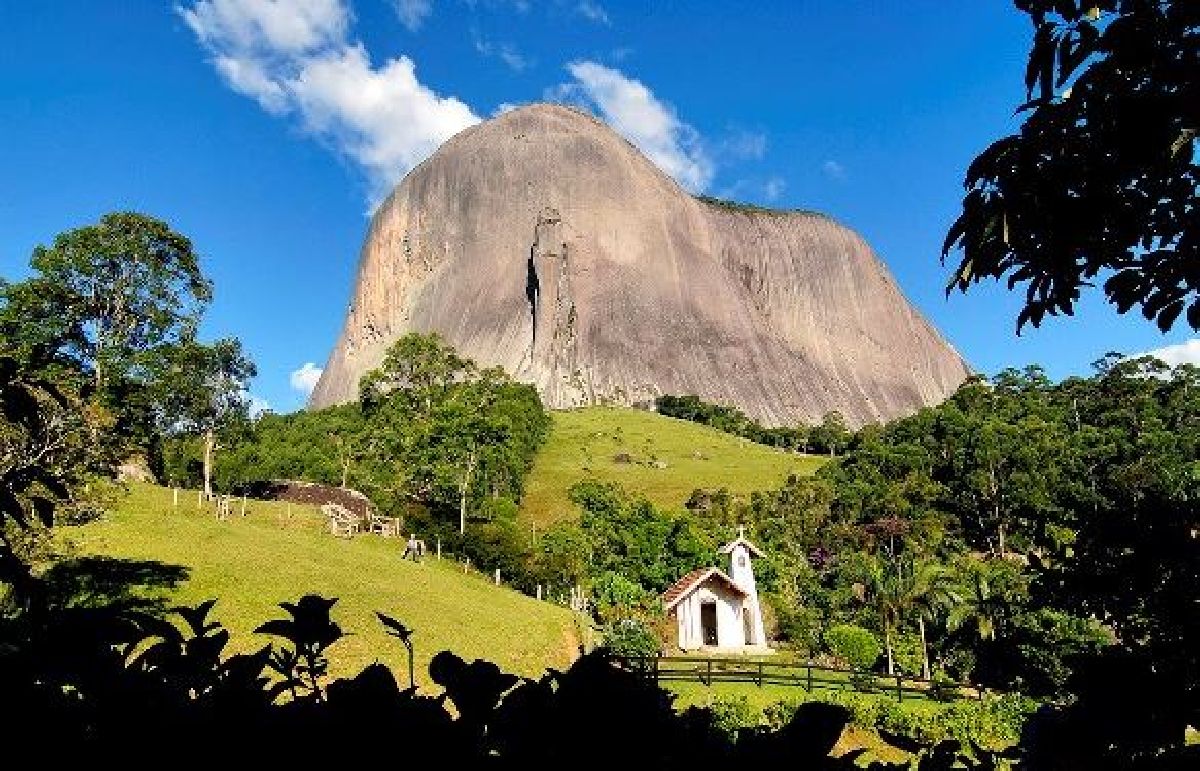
left=164, top=334, right=550, bottom=540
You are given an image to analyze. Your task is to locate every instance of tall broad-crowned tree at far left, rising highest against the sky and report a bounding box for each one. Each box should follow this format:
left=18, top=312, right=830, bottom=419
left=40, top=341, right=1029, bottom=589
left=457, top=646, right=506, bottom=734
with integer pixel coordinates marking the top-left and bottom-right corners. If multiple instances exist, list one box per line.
left=0, top=213, right=211, bottom=450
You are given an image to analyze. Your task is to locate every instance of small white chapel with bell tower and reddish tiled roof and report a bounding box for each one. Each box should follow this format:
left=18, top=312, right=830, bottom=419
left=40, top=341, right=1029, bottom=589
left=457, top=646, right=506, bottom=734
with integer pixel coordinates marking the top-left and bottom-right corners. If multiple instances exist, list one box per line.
left=662, top=527, right=770, bottom=653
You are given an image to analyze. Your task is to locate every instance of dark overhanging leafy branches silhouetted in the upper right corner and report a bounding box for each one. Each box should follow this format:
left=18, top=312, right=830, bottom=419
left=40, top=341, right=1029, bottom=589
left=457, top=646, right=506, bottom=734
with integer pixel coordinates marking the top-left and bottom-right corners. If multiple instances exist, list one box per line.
left=943, top=0, right=1200, bottom=331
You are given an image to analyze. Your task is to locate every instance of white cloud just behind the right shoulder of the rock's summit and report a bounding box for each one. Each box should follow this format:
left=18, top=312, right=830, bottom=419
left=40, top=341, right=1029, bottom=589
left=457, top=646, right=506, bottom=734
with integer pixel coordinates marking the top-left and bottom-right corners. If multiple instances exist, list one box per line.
left=547, top=61, right=714, bottom=192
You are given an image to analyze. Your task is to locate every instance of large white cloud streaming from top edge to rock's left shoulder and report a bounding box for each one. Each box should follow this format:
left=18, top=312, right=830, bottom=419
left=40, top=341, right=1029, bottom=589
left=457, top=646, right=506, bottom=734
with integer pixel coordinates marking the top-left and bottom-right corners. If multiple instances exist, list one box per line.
left=179, top=0, right=480, bottom=202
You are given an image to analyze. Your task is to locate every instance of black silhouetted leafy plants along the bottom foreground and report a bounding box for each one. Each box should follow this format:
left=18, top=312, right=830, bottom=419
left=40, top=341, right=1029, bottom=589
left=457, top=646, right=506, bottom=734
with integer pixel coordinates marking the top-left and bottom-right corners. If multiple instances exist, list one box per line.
left=0, top=594, right=1027, bottom=770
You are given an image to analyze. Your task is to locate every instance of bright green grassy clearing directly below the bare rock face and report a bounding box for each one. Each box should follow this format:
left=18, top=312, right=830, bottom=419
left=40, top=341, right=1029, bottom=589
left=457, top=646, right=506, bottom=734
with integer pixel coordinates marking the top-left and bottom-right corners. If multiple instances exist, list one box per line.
left=521, top=407, right=823, bottom=524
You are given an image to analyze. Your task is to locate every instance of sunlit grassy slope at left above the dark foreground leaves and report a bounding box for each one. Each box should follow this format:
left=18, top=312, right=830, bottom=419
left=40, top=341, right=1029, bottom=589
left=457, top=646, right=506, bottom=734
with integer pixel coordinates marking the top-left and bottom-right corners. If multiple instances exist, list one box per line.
left=60, top=484, right=576, bottom=681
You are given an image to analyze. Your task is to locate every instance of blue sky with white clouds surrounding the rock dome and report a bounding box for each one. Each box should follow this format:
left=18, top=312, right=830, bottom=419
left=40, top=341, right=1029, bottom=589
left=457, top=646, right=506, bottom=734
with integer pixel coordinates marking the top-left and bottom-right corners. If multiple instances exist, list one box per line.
left=0, top=0, right=1200, bottom=412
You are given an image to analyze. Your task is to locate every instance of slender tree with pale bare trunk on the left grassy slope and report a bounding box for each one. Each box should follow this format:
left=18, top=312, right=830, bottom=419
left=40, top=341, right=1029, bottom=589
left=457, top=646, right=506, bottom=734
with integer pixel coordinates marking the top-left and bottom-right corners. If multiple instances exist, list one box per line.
left=162, top=337, right=257, bottom=497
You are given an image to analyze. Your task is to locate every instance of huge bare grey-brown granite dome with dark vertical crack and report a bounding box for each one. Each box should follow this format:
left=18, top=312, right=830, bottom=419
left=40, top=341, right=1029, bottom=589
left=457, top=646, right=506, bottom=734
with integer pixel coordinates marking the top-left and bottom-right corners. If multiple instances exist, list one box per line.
left=310, top=104, right=968, bottom=425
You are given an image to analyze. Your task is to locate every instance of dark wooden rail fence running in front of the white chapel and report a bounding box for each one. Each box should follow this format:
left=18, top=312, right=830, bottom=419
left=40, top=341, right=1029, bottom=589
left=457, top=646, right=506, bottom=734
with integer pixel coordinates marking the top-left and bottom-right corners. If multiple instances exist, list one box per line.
left=616, top=656, right=983, bottom=701
